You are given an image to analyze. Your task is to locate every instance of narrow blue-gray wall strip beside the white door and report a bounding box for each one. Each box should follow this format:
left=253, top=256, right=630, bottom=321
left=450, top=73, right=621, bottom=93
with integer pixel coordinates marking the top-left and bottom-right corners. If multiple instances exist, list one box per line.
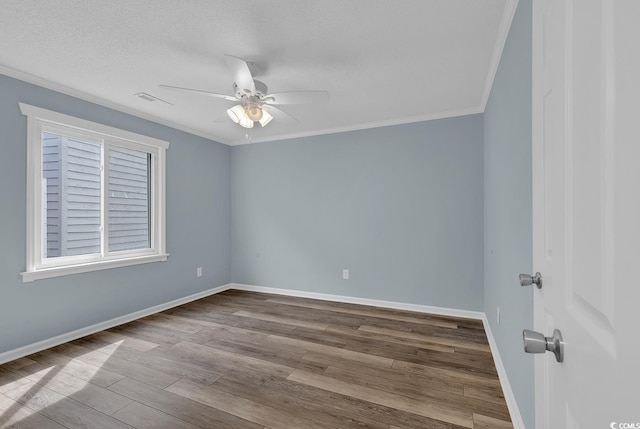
left=484, top=0, right=535, bottom=428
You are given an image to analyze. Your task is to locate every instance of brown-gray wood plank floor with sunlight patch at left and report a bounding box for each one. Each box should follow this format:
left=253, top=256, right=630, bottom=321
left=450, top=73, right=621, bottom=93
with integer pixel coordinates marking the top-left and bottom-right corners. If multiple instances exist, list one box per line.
left=0, top=290, right=513, bottom=429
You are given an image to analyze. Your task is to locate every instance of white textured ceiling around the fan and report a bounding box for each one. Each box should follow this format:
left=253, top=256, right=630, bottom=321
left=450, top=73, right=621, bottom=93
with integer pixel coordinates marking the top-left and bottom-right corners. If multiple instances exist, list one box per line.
left=0, top=0, right=516, bottom=144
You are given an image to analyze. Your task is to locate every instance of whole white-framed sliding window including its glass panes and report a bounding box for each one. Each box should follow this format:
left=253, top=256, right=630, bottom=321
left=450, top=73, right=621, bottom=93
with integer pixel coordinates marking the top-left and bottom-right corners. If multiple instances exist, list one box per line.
left=19, top=103, right=169, bottom=281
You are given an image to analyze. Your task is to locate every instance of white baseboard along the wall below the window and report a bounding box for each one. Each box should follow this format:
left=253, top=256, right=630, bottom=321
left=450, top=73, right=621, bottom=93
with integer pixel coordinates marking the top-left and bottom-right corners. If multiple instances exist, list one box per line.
left=0, top=284, right=230, bottom=365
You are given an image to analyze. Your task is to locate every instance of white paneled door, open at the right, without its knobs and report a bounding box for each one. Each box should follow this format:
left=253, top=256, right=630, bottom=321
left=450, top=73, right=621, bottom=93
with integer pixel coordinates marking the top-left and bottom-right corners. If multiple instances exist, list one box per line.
left=533, top=0, right=640, bottom=429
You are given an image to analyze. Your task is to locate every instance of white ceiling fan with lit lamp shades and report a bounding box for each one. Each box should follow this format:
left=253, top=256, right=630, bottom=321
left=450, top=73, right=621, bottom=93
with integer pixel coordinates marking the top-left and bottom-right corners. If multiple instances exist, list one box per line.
left=160, top=55, right=329, bottom=128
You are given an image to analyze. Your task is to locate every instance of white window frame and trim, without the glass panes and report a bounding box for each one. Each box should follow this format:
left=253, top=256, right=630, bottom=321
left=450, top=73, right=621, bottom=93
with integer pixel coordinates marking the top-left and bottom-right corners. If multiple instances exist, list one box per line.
left=18, top=103, right=169, bottom=282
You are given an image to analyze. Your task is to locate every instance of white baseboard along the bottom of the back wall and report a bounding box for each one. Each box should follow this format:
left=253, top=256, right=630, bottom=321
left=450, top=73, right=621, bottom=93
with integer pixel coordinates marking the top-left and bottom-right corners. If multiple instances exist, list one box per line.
left=229, top=283, right=484, bottom=320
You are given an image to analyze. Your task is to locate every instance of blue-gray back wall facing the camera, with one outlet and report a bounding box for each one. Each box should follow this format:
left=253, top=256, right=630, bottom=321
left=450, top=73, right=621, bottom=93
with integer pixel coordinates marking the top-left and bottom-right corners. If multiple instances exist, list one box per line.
left=231, top=115, right=483, bottom=310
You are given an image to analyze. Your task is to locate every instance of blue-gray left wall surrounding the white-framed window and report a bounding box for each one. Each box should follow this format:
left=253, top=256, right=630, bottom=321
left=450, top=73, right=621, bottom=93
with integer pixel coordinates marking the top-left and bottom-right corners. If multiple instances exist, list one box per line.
left=0, top=75, right=231, bottom=353
